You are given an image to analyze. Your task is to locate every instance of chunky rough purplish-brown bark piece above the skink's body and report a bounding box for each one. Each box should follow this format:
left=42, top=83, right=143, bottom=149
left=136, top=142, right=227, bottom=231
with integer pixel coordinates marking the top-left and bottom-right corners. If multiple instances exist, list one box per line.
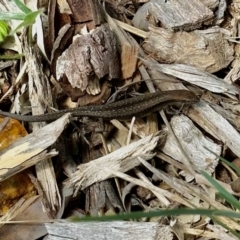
left=56, top=24, right=120, bottom=97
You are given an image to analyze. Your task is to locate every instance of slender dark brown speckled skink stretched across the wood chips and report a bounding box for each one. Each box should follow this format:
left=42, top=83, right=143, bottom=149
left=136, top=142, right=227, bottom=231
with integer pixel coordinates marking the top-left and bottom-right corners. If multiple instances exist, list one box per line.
left=0, top=90, right=199, bottom=122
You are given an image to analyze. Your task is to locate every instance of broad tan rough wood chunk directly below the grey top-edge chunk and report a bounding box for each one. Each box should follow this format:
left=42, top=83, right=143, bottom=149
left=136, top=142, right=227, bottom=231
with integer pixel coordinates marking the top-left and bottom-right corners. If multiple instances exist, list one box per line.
left=143, top=27, right=234, bottom=73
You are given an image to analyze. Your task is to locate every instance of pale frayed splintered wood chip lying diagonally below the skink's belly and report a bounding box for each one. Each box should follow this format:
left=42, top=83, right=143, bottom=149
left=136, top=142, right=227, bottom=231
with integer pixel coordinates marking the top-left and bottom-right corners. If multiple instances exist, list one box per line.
left=66, top=135, right=159, bottom=193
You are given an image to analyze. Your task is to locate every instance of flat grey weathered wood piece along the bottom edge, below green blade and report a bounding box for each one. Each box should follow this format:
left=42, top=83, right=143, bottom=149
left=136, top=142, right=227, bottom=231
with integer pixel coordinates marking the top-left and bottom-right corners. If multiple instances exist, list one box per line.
left=45, top=221, right=173, bottom=240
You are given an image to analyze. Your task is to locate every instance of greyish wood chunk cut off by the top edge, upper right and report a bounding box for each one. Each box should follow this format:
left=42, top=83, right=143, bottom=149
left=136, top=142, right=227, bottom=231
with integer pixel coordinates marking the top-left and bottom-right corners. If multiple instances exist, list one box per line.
left=133, top=0, right=214, bottom=31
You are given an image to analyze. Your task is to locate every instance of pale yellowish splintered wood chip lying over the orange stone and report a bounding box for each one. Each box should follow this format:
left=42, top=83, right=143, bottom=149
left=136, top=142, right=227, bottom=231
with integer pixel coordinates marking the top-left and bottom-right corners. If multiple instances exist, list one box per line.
left=0, top=114, right=69, bottom=181
